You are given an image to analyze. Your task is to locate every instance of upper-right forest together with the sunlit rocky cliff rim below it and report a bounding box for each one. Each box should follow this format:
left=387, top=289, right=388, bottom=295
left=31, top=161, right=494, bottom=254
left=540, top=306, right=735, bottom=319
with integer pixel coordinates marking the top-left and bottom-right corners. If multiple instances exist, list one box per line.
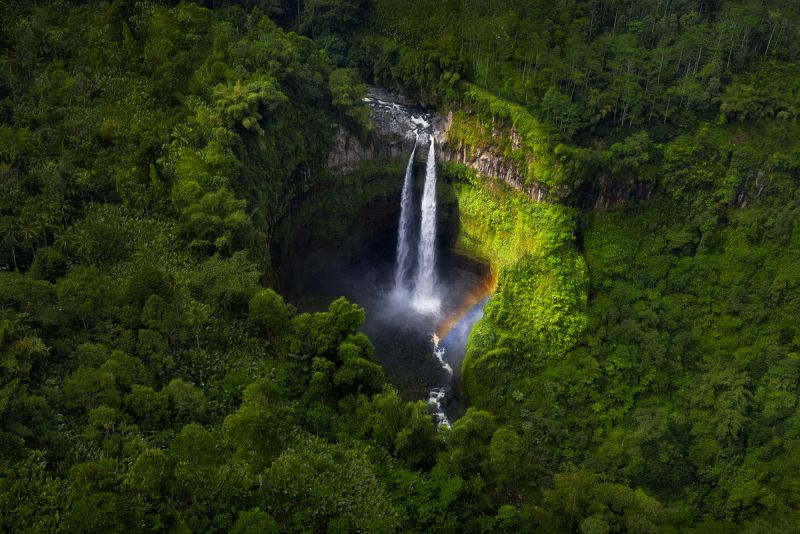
left=349, top=0, right=800, bottom=200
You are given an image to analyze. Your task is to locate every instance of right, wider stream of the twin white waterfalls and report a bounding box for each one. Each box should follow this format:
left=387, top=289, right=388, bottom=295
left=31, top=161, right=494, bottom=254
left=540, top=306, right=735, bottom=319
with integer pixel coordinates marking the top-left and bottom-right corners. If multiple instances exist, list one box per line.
left=412, top=136, right=439, bottom=313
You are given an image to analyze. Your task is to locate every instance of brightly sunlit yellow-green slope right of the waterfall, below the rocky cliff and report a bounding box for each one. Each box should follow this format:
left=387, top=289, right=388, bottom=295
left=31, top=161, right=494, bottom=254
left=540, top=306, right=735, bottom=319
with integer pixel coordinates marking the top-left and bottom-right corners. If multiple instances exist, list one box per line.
left=445, top=164, right=588, bottom=406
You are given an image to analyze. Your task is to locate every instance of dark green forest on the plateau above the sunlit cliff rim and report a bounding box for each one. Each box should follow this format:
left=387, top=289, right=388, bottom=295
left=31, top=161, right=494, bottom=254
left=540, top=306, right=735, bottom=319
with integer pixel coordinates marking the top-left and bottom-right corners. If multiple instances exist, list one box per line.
left=364, top=0, right=800, bottom=140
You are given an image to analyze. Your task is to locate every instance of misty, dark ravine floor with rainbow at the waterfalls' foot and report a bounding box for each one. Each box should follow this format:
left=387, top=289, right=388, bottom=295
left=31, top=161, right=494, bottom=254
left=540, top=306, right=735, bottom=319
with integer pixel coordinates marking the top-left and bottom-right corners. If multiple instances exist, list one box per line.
left=290, top=220, right=492, bottom=421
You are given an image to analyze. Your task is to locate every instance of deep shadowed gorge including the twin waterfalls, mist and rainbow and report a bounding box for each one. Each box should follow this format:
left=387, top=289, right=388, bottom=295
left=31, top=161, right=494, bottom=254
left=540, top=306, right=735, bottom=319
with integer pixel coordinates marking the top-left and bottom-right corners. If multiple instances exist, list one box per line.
left=280, top=91, right=494, bottom=424
